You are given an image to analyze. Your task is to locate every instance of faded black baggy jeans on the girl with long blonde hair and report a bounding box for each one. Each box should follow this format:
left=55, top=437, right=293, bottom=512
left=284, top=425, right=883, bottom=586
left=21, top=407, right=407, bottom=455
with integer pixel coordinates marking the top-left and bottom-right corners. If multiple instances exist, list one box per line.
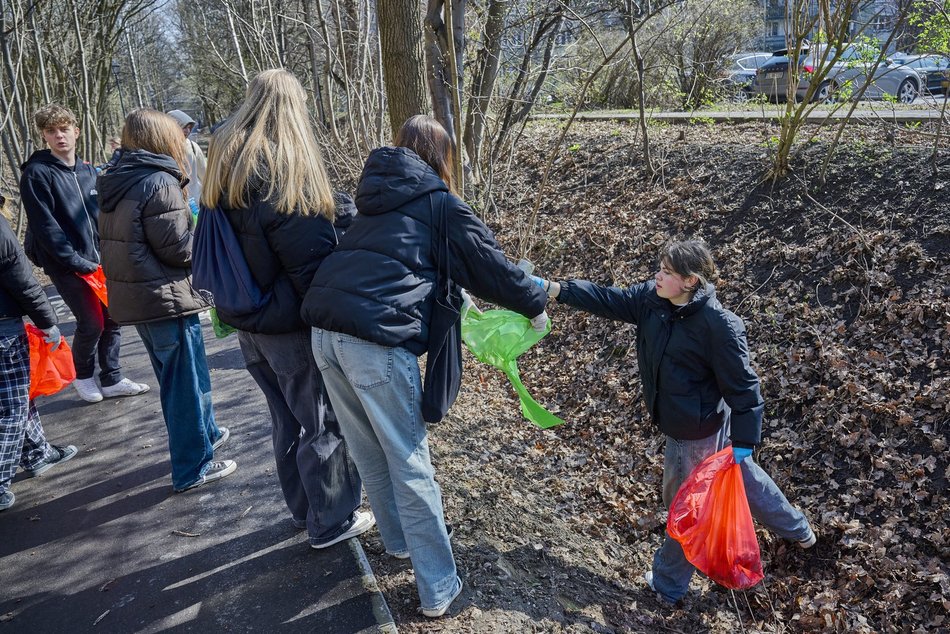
left=238, top=328, right=362, bottom=544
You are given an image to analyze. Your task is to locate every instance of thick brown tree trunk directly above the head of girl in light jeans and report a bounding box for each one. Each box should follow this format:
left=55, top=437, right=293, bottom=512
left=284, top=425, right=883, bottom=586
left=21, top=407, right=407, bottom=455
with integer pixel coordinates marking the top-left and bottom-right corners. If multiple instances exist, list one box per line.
left=377, top=0, right=429, bottom=135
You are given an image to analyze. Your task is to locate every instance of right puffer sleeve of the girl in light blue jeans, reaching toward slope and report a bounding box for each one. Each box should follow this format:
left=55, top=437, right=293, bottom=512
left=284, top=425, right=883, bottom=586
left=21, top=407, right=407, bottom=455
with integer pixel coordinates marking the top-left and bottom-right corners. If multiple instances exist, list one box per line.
left=446, top=194, right=548, bottom=319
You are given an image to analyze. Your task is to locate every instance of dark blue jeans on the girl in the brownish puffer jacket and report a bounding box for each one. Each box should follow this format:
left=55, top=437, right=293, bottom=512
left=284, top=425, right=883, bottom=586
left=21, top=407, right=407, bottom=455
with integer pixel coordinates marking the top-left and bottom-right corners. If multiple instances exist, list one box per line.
left=135, top=315, right=221, bottom=489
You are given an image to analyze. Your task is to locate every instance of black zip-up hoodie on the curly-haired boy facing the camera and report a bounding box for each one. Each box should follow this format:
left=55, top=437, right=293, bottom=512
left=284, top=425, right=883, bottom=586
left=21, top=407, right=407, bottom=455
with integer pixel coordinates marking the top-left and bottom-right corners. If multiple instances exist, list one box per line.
left=20, top=150, right=99, bottom=274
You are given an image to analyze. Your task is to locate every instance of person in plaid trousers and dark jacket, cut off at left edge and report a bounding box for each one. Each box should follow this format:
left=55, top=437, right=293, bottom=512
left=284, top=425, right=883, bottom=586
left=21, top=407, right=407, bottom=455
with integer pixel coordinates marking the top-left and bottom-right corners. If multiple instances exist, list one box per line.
left=0, top=196, right=76, bottom=511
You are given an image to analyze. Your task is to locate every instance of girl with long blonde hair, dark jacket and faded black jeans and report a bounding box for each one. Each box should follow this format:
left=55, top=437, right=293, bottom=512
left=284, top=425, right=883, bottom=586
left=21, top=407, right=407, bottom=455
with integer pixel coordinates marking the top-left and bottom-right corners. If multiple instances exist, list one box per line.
left=199, top=69, right=375, bottom=548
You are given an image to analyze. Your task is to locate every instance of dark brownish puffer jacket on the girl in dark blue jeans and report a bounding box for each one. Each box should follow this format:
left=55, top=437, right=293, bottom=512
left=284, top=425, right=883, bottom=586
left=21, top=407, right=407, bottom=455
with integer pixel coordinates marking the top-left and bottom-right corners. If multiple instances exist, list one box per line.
left=99, top=150, right=209, bottom=324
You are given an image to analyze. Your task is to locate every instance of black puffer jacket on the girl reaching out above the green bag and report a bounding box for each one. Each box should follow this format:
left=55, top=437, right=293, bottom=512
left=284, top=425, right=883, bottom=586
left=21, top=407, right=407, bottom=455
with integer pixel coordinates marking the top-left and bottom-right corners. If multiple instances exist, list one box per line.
left=301, top=147, right=547, bottom=355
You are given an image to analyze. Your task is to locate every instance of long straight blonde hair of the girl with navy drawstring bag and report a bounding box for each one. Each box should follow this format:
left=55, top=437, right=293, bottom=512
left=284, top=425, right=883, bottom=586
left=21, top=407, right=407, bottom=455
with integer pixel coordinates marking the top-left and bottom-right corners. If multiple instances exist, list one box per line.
left=201, top=68, right=335, bottom=215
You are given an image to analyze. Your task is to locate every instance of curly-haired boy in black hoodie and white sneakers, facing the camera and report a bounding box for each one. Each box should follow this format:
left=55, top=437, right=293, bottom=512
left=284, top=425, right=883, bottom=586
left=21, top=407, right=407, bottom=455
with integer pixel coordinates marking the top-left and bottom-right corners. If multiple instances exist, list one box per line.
left=20, top=104, right=149, bottom=403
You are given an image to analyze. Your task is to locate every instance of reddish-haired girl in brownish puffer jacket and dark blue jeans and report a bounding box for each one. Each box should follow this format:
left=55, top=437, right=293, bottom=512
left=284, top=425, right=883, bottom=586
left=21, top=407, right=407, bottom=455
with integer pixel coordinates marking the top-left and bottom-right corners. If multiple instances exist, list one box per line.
left=98, top=108, right=236, bottom=492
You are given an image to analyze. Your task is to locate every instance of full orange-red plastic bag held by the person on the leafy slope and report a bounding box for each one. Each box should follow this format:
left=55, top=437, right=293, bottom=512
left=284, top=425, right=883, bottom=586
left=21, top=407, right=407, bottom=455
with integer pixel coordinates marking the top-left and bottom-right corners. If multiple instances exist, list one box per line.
left=666, top=447, right=764, bottom=590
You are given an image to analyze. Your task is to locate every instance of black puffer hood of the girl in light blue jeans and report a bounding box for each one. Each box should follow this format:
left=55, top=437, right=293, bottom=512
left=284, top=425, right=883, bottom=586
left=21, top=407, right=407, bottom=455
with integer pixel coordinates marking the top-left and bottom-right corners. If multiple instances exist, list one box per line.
left=356, top=147, right=449, bottom=216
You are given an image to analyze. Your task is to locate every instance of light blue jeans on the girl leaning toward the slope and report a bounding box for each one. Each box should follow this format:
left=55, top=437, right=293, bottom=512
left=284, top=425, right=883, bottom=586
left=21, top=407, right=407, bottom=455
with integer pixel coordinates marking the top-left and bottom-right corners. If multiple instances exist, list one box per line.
left=312, top=328, right=458, bottom=609
